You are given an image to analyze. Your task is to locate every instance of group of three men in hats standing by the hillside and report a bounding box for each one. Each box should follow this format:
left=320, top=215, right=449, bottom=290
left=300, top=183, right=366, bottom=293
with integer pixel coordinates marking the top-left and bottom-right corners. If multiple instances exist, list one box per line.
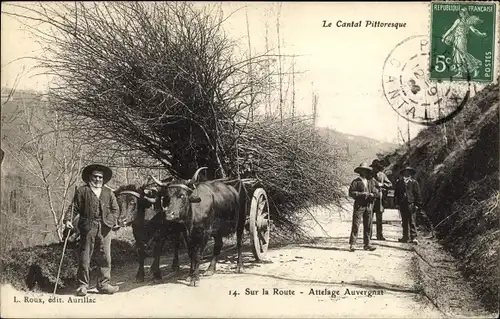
left=349, top=159, right=422, bottom=252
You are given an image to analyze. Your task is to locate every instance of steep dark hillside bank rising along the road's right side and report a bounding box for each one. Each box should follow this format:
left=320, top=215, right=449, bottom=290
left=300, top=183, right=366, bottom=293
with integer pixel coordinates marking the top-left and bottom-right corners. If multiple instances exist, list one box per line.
left=386, top=84, right=500, bottom=310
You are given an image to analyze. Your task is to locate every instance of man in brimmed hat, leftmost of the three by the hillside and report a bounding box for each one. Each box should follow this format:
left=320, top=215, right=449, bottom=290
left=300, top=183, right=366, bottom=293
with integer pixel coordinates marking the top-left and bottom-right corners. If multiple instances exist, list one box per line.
left=349, top=163, right=379, bottom=251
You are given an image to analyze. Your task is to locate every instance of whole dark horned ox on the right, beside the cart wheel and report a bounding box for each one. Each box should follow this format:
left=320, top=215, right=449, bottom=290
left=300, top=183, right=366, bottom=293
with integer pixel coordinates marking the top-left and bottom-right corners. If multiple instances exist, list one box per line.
left=151, top=167, right=247, bottom=286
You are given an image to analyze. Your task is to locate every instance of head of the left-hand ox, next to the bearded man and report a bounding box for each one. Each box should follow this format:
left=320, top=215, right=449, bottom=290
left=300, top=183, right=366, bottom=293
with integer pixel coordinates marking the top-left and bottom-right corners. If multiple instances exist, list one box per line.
left=115, top=185, right=157, bottom=227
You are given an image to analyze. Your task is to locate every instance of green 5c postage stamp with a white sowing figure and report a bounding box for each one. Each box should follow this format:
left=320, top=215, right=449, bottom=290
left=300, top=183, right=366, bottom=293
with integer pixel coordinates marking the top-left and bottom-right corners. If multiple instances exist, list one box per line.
left=430, top=1, right=497, bottom=83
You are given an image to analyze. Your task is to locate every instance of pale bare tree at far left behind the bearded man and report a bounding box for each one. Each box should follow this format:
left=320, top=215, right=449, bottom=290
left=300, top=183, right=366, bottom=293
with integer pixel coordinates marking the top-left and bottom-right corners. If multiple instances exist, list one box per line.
left=2, top=94, right=83, bottom=239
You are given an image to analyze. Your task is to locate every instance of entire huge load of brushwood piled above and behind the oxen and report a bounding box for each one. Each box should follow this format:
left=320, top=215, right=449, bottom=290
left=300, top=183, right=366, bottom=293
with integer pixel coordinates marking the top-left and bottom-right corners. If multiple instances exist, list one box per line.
left=0, top=2, right=348, bottom=290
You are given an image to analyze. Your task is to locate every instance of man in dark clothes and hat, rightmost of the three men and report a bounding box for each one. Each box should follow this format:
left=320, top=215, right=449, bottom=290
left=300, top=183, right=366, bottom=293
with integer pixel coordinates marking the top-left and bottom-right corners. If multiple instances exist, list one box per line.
left=394, top=166, right=422, bottom=244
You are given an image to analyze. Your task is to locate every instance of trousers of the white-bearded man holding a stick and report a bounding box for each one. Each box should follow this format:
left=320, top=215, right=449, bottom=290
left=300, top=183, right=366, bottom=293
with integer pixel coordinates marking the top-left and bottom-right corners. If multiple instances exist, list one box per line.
left=77, top=220, right=113, bottom=289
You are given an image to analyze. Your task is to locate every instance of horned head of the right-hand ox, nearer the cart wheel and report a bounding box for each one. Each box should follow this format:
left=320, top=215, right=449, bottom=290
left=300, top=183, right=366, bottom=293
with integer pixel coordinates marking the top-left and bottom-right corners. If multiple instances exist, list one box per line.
left=153, top=167, right=207, bottom=222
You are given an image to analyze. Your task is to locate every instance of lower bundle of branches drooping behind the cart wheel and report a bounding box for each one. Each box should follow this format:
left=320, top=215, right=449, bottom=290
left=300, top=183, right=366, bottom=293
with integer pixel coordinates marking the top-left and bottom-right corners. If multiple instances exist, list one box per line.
left=237, top=118, right=343, bottom=231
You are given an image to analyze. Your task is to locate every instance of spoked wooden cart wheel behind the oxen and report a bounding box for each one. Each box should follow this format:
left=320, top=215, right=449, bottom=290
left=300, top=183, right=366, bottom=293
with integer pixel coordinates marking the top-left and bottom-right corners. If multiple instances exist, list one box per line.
left=249, top=188, right=271, bottom=261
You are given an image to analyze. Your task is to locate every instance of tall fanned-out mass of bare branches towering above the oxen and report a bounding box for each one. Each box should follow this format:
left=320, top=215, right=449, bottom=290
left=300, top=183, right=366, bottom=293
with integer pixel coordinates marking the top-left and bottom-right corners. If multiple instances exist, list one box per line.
left=7, top=2, right=265, bottom=178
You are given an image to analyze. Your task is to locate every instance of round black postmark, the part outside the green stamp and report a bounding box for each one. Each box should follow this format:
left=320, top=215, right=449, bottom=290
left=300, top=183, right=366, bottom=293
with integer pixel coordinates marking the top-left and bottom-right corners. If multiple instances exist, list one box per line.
left=382, top=35, right=470, bottom=126
